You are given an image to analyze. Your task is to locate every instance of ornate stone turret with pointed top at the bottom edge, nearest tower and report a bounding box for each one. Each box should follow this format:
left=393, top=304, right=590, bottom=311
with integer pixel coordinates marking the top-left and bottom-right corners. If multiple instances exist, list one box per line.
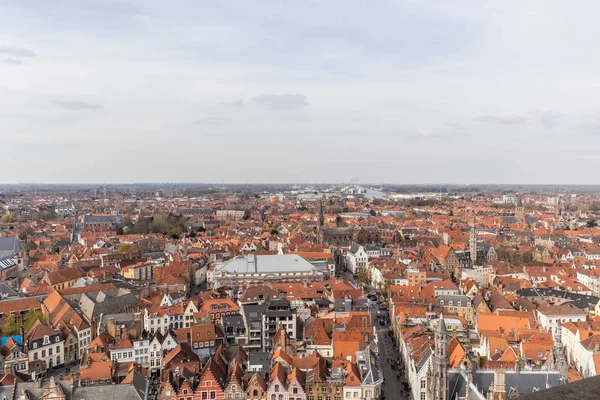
left=428, top=315, right=448, bottom=400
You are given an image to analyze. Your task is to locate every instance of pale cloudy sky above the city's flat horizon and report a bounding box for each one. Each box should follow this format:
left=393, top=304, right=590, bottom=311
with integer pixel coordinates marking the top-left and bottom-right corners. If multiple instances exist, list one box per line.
left=0, top=0, right=600, bottom=184
